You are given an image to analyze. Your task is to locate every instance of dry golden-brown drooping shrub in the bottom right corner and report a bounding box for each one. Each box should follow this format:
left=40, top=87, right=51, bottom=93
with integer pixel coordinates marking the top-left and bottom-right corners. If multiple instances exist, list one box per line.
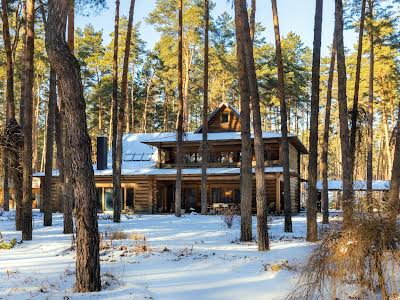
left=288, top=212, right=400, bottom=299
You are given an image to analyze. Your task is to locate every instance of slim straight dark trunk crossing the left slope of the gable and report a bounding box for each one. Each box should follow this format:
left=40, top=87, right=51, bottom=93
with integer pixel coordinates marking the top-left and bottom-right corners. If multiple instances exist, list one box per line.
left=201, top=0, right=210, bottom=215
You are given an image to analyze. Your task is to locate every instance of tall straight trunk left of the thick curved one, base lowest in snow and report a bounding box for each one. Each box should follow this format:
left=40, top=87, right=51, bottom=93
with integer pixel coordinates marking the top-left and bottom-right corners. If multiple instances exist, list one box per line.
left=22, top=0, right=35, bottom=241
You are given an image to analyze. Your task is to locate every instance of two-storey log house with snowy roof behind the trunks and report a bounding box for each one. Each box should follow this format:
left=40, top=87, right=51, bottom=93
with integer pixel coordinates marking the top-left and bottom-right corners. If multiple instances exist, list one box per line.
left=36, top=104, right=307, bottom=214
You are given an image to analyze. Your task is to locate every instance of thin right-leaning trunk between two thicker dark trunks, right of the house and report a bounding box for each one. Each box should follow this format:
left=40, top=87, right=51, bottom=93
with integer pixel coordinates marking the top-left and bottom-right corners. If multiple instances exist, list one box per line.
left=321, top=29, right=336, bottom=224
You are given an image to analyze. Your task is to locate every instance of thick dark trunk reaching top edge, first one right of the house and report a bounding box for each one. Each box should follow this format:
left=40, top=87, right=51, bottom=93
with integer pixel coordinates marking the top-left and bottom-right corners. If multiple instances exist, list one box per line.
left=307, top=0, right=323, bottom=242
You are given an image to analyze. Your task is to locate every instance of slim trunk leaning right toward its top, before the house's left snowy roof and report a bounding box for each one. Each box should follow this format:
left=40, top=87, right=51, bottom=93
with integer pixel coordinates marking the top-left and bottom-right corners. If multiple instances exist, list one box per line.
left=113, top=0, right=135, bottom=222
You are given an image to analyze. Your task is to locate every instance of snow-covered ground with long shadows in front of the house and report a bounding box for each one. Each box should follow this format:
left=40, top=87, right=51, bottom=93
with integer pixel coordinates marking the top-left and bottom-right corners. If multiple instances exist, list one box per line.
left=0, top=211, right=313, bottom=300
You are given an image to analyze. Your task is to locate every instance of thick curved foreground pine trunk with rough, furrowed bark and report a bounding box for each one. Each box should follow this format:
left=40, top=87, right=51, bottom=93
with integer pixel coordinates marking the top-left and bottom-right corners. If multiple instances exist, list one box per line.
left=46, top=0, right=101, bottom=292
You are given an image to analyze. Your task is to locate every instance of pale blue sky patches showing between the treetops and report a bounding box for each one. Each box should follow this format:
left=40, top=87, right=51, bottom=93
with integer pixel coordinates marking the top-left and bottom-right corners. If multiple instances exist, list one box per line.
left=76, top=0, right=356, bottom=55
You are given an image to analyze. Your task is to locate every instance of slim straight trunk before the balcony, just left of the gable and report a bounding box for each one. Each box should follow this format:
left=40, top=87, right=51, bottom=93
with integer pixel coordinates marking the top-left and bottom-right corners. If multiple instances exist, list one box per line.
left=175, top=0, right=184, bottom=217
